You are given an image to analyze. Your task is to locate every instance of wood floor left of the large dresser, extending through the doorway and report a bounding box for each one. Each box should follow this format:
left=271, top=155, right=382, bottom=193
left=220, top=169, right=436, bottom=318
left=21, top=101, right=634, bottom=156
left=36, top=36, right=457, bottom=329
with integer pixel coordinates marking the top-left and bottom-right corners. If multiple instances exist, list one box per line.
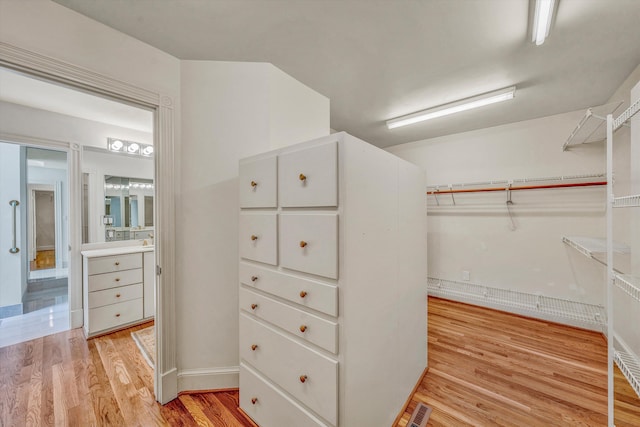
left=0, top=323, right=252, bottom=427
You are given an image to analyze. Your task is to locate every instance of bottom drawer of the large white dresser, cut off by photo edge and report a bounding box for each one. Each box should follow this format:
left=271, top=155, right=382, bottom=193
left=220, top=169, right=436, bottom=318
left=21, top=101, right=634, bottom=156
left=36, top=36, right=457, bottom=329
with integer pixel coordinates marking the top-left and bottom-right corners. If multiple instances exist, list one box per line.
left=240, top=363, right=327, bottom=427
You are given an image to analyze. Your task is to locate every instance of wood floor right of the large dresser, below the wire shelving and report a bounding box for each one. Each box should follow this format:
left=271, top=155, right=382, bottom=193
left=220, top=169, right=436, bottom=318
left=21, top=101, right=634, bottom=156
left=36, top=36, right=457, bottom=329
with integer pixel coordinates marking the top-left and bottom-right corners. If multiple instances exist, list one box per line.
left=397, top=298, right=640, bottom=427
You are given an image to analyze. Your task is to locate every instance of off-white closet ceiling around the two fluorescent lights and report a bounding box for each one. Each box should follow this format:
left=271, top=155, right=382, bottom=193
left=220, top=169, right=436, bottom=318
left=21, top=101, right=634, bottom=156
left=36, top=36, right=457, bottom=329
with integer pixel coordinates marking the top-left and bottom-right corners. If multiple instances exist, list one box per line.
left=36, top=0, right=640, bottom=147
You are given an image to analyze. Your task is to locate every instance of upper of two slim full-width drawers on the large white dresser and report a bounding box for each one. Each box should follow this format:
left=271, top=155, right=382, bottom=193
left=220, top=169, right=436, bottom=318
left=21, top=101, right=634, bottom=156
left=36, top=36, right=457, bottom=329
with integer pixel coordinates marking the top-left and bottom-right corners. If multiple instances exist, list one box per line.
left=240, top=262, right=338, bottom=317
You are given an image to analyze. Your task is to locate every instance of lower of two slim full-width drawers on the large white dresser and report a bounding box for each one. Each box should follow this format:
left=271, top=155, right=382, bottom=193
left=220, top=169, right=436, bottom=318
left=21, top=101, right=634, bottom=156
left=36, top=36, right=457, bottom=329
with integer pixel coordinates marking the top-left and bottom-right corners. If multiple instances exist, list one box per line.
left=240, top=288, right=338, bottom=354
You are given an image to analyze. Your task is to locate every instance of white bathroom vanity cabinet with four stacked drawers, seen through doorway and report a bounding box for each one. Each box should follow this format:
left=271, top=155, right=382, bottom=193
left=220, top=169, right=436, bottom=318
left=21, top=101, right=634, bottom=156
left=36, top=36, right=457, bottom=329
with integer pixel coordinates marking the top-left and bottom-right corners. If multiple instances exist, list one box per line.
left=82, top=246, right=155, bottom=338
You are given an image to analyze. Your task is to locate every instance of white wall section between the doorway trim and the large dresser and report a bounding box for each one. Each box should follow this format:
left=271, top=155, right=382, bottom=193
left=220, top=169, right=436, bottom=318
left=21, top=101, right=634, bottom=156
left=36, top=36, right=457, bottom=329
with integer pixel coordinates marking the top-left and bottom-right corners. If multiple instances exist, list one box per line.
left=176, top=61, right=329, bottom=389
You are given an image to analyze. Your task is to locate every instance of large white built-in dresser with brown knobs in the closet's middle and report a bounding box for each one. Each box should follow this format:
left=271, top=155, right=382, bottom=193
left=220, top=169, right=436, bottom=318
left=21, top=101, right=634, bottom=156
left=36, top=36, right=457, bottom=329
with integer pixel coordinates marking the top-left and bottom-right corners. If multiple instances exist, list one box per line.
left=239, top=133, right=427, bottom=427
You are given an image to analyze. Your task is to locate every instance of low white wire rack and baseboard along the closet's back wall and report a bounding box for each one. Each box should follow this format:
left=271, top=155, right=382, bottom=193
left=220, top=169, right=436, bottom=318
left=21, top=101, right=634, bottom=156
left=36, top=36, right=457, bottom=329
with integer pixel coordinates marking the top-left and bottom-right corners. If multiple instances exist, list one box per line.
left=427, top=277, right=607, bottom=333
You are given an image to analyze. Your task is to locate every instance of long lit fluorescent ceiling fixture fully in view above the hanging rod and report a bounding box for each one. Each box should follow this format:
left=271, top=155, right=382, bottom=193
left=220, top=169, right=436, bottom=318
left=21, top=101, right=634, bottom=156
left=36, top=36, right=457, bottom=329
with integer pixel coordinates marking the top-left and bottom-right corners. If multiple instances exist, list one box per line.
left=387, top=86, right=516, bottom=129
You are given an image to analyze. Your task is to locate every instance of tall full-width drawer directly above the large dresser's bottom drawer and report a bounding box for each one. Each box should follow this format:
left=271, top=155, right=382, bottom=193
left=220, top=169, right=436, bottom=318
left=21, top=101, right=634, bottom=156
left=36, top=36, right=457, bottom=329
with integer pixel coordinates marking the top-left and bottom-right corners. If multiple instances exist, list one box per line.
left=240, top=314, right=338, bottom=425
